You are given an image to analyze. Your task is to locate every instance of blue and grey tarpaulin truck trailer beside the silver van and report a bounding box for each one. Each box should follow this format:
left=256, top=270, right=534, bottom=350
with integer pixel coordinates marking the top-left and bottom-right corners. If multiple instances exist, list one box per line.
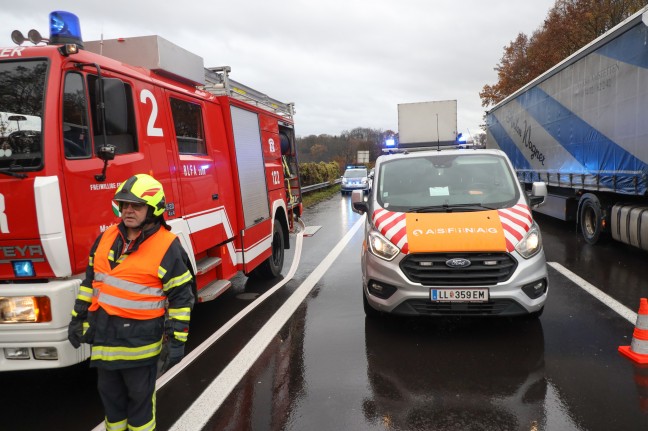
left=486, top=6, right=648, bottom=250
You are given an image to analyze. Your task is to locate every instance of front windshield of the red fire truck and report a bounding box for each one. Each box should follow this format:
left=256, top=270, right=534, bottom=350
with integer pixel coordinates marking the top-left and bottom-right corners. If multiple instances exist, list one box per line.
left=0, top=59, right=47, bottom=171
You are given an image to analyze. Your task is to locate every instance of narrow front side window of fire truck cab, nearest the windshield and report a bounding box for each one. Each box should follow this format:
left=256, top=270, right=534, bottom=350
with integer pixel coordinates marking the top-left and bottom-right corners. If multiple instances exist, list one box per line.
left=63, top=72, right=92, bottom=159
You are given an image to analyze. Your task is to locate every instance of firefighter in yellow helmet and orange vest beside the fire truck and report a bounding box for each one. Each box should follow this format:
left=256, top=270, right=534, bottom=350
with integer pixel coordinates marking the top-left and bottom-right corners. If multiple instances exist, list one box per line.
left=68, top=174, right=194, bottom=431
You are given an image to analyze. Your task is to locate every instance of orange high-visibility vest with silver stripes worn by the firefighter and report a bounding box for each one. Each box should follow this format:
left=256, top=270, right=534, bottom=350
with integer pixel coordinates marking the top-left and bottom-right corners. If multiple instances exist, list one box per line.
left=89, top=226, right=176, bottom=320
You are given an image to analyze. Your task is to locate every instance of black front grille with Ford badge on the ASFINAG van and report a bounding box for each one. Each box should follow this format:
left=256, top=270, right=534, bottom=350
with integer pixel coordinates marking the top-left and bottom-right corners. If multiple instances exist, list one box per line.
left=400, top=253, right=517, bottom=286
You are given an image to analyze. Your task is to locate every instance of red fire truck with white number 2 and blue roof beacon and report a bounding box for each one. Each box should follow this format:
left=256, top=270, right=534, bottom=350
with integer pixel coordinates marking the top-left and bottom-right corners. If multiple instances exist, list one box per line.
left=0, top=11, right=302, bottom=371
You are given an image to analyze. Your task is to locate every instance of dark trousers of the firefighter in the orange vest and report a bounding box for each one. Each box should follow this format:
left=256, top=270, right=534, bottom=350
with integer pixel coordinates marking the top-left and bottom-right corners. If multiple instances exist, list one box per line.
left=97, top=363, right=157, bottom=430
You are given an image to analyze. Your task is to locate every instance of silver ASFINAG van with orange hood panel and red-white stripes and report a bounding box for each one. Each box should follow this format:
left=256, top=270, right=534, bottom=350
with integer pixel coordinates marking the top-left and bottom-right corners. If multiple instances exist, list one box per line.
left=352, top=149, right=548, bottom=317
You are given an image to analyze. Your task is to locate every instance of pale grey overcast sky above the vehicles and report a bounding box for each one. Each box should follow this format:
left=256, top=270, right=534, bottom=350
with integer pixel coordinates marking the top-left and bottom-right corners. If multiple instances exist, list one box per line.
left=0, top=0, right=555, bottom=136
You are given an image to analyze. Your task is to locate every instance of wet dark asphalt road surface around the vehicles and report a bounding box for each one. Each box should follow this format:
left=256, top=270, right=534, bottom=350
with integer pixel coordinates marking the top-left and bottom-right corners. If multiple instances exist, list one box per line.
left=5, top=197, right=648, bottom=430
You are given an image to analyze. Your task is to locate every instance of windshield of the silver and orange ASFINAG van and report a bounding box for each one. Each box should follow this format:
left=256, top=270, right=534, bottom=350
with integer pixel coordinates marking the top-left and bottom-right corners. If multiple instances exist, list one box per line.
left=376, top=154, right=520, bottom=212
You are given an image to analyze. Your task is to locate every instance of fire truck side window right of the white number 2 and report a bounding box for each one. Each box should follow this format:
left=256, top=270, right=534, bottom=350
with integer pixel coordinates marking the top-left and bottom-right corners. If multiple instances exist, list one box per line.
left=170, top=98, right=207, bottom=154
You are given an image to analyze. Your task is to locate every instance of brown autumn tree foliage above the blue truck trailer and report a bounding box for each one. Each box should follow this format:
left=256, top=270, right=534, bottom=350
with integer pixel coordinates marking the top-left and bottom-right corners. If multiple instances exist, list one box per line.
left=479, top=0, right=646, bottom=107
